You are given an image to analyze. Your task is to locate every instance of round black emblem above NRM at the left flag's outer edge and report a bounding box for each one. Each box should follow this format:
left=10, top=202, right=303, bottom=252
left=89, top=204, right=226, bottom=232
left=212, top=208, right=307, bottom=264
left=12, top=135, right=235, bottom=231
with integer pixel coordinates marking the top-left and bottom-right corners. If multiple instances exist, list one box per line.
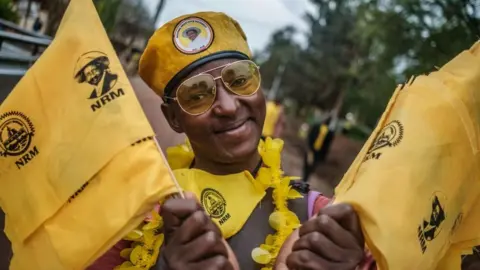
left=0, top=111, right=39, bottom=169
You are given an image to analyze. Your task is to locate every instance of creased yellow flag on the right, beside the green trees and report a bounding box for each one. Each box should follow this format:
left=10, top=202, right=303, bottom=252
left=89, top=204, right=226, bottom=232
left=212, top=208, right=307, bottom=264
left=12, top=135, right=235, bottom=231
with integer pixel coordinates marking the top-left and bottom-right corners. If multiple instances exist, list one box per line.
left=336, top=43, right=480, bottom=270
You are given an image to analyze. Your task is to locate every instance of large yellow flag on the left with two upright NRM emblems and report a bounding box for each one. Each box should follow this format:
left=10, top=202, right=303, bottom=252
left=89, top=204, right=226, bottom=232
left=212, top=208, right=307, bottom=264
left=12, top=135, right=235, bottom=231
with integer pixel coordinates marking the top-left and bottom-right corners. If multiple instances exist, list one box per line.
left=0, top=0, right=178, bottom=270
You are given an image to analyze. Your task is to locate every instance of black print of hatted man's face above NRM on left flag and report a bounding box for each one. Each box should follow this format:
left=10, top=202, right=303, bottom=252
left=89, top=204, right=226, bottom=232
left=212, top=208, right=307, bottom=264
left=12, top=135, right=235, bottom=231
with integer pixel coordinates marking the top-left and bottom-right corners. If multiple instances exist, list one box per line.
left=75, top=51, right=125, bottom=112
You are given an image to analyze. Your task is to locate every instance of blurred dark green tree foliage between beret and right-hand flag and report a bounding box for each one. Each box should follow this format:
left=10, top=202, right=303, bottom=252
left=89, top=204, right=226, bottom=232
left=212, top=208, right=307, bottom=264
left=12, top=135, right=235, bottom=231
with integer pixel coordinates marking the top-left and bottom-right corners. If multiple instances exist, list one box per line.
left=262, top=0, right=480, bottom=127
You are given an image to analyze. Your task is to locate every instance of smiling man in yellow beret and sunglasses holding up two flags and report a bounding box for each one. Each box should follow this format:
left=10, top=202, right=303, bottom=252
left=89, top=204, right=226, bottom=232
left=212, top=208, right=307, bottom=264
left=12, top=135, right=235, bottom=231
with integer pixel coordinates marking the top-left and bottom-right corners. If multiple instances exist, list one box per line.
left=89, top=9, right=371, bottom=270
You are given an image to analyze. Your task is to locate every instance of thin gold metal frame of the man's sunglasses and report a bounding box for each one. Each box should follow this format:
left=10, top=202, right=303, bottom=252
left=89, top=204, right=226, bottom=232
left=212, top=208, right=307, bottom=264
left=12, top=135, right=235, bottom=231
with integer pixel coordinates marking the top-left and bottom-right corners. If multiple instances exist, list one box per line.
left=164, top=60, right=262, bottom=116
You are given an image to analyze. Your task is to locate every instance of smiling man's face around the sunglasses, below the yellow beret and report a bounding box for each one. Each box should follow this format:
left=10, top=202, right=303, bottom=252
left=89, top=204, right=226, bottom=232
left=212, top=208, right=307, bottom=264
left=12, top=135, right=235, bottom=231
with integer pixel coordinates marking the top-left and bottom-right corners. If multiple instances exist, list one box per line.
left=166, top=59, right=265, bottom=164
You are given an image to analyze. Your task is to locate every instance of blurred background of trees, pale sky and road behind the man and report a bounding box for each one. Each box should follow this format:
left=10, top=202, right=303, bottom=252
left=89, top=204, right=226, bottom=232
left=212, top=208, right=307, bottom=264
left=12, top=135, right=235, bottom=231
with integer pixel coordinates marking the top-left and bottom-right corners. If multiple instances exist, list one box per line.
left=0, top=0, right=480, bottom=269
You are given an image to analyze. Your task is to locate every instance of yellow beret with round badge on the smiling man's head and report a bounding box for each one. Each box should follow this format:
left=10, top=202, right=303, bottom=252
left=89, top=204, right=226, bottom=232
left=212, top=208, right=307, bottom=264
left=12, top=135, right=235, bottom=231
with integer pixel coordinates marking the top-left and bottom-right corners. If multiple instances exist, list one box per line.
left=138, top=12, right=252, bottom=96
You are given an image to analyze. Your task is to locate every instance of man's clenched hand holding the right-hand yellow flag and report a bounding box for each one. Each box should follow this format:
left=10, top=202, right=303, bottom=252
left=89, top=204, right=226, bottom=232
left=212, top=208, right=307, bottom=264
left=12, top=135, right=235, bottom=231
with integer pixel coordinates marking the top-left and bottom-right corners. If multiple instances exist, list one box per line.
left=277, top=204, right=364, bottom=270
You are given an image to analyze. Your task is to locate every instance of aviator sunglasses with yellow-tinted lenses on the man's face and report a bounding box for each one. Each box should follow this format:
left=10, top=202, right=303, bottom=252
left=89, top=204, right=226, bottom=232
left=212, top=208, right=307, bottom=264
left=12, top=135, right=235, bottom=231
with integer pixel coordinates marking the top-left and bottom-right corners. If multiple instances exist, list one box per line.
left=164, top=60, right=261, bottom=115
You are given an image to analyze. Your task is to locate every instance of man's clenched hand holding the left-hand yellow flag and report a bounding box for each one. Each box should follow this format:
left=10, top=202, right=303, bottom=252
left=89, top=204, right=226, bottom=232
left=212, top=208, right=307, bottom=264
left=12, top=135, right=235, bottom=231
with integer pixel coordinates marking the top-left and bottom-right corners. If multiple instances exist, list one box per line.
left=160, top=193, right=235, bottom=270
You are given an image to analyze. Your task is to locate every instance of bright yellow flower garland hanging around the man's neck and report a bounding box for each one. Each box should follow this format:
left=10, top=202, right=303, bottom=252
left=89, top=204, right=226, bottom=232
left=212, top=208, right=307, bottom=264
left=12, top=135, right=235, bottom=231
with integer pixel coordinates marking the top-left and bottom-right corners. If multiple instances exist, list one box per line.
left=115, top=138, right=302, bottom=270
